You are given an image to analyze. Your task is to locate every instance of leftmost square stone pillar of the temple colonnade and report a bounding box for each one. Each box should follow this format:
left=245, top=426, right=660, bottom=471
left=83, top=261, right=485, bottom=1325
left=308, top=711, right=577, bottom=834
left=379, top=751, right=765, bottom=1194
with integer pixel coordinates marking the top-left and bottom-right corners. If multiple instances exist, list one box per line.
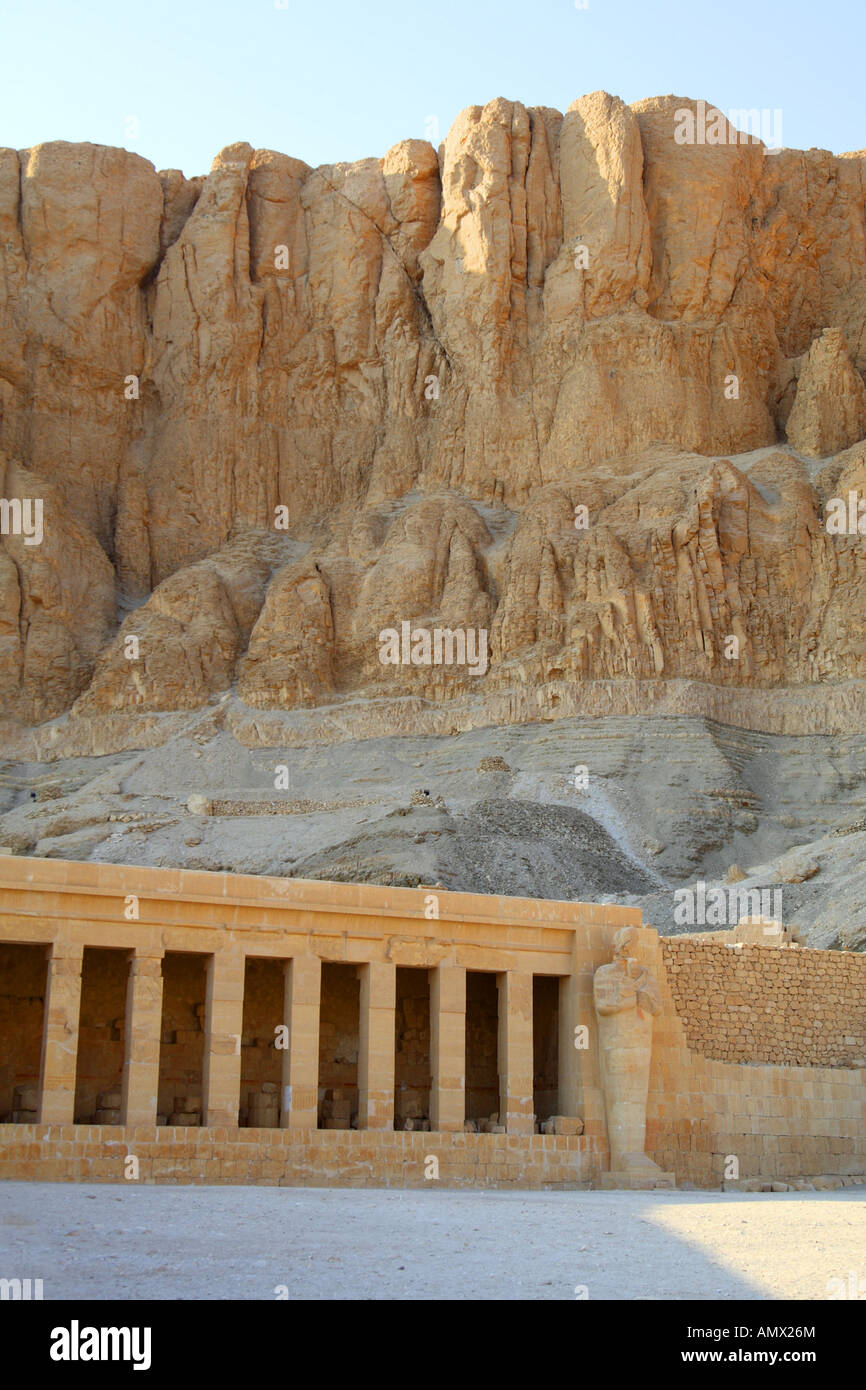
left=39, top=941, right=85, bottom=1125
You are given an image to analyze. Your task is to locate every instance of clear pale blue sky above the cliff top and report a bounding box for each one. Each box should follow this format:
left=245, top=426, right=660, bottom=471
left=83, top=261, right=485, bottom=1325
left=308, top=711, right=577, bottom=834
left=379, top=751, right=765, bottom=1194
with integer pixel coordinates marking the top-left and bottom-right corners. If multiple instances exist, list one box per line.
left=0, top=0, right=866, bottom=177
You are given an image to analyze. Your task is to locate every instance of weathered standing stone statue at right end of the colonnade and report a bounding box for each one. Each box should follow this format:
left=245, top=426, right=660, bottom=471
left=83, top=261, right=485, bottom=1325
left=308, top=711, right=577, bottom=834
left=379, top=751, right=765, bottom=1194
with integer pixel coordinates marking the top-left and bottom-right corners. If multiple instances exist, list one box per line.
left=592, top=927, right=673, bottom=1187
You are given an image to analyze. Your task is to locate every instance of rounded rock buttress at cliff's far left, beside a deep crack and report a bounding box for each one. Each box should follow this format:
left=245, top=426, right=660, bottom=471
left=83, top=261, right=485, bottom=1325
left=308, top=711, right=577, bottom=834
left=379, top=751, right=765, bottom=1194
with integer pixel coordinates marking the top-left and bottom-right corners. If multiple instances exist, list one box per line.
left=0, top=140, right=163, bottom=553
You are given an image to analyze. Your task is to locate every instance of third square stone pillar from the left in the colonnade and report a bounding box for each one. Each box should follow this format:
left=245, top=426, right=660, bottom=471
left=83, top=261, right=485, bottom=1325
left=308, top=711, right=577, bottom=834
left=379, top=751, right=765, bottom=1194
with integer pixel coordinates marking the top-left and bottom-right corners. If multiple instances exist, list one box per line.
left=202, top=949, right=245, bottom=1129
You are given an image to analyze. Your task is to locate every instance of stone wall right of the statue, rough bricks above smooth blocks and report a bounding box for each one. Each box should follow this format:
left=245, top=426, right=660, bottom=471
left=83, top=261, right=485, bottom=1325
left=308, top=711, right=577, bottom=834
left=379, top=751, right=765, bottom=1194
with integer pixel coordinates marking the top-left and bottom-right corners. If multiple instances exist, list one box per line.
left=645, top=938, right=866, bottom=1187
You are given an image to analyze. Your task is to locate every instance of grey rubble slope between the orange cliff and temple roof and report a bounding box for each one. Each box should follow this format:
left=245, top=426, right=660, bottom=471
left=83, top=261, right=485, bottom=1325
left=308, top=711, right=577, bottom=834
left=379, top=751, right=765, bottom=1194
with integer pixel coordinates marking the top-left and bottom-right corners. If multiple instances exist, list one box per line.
left=0, top=702, right=866, bottom=949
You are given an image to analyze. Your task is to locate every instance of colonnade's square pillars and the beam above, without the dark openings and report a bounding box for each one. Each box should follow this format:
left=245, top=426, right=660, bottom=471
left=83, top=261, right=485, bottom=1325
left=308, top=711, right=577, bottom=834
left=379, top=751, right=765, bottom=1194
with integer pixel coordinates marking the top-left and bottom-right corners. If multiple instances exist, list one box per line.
left=0, top=858, right=639, bottom=1137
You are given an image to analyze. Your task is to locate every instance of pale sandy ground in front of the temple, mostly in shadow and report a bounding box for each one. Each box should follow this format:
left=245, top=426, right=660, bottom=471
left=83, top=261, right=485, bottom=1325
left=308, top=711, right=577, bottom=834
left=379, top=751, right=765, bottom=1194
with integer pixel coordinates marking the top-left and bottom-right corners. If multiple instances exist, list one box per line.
left=0, top=1183, right=866, bottom=1301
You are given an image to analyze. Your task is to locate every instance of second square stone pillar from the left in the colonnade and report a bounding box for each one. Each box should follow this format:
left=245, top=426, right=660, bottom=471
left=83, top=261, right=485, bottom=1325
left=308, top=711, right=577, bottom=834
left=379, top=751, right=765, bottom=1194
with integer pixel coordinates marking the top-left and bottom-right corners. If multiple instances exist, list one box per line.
left=121, top=951, right=163, bottom=1125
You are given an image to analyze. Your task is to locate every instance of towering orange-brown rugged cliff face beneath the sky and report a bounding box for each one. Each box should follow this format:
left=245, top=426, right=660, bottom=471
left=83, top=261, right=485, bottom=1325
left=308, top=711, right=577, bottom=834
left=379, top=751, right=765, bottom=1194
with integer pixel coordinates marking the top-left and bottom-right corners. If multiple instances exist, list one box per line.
left=0, top=93, right=866, bottom=751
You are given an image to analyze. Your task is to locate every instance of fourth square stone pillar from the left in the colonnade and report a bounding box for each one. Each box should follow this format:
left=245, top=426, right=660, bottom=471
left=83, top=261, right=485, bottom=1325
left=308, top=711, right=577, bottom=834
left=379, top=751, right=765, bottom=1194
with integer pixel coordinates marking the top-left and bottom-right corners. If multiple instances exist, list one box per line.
left=279, top=956, right=321, bottom=1130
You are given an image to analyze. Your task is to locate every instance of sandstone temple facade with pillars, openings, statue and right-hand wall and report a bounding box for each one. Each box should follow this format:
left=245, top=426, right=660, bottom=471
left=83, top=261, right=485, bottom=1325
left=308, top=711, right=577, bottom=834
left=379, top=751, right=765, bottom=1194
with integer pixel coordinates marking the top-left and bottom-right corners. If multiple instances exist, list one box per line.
left=0, top=856, right=866, bottom=1187
